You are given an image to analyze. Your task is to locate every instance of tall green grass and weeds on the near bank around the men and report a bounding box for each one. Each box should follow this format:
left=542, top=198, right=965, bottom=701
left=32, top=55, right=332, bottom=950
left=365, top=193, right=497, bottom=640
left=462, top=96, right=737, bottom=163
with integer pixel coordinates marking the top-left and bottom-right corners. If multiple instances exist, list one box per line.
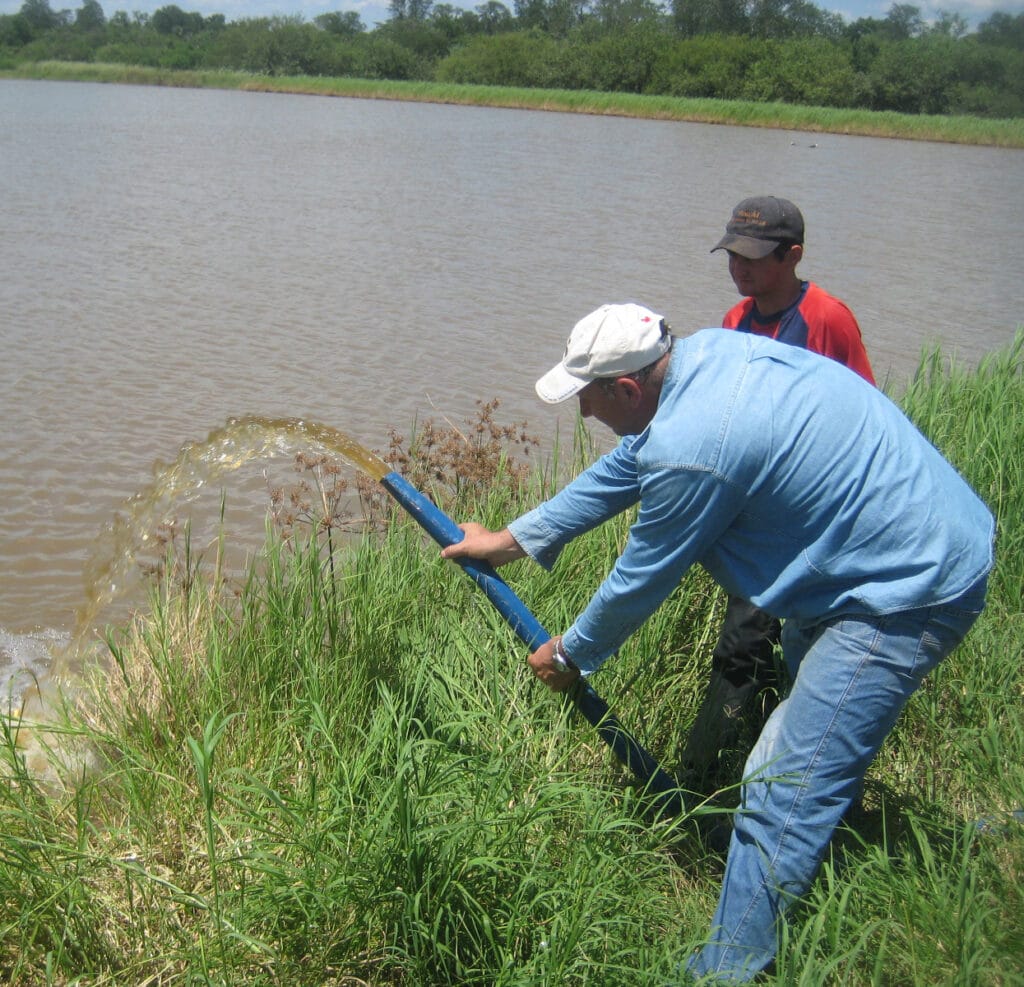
left=0, top=330, right=1024, bottom=987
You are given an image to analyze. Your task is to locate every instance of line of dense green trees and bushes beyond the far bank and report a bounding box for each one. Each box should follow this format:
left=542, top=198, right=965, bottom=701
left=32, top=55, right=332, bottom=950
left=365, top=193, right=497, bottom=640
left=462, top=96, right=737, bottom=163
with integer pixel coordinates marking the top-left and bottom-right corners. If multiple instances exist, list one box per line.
left=0, top=0, right=1024, bottom=118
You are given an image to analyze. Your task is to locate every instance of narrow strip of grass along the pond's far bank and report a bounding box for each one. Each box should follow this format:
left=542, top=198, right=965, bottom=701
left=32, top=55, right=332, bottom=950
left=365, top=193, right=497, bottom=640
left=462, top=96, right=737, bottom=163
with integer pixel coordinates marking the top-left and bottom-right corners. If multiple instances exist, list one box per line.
left=8, top=61, right=1024, bottom=148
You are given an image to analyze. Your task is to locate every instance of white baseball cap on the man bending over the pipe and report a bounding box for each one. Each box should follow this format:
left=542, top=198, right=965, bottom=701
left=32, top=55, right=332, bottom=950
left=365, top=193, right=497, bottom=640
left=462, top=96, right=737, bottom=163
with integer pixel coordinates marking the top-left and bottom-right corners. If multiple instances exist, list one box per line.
left=537, top=302, right=672, bottom=404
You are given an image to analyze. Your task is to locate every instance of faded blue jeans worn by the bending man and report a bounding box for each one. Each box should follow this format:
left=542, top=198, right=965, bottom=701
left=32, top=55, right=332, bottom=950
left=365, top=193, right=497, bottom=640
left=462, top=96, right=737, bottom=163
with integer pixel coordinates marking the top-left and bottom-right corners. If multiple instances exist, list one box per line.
left=687, top=578, right=986, bottom=983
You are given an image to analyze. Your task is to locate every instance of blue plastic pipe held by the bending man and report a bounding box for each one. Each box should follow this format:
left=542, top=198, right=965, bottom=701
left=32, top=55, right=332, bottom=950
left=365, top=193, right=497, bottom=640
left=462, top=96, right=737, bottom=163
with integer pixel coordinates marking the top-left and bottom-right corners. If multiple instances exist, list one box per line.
left=380, top=472, right=684, bottom=815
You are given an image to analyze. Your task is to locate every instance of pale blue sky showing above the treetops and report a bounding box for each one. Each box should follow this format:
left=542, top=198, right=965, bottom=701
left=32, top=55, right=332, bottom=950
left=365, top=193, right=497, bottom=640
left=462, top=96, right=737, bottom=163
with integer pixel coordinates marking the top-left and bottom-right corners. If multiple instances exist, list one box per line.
left=0, top=0, right=1024, bottom=28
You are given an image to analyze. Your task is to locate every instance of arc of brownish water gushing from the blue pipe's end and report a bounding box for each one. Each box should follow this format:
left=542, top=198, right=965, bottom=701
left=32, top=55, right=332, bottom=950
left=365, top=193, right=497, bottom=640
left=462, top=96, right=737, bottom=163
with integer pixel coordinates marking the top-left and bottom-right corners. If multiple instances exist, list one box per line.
left=10, top=416, right=391, bottom=782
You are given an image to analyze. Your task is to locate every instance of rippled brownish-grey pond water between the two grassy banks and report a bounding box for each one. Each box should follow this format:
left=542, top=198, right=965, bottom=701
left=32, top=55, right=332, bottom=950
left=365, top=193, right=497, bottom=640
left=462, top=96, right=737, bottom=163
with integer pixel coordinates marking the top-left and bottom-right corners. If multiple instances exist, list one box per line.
left=0, top=80, right=1024, bottom=682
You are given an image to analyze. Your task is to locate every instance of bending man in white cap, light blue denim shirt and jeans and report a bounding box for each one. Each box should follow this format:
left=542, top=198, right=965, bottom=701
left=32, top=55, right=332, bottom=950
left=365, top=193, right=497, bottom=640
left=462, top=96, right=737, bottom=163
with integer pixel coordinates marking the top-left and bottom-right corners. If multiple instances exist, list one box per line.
left=442, top=304, right=994, bottom=983
